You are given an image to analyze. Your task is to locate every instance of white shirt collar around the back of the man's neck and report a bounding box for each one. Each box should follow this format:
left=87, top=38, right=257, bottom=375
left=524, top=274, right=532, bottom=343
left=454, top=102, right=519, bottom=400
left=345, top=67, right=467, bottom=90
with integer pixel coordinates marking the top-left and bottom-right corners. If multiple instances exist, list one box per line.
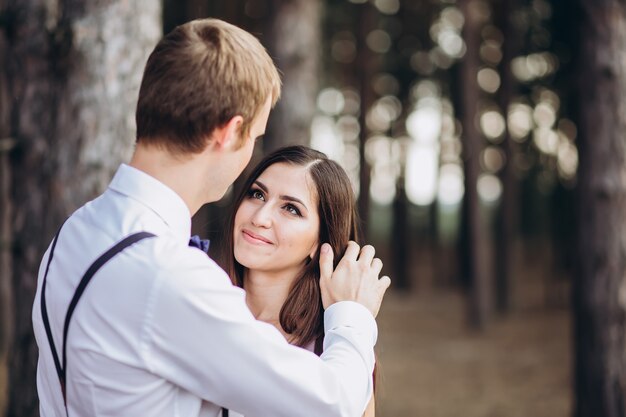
left=109, top=164, right=191, bottom=243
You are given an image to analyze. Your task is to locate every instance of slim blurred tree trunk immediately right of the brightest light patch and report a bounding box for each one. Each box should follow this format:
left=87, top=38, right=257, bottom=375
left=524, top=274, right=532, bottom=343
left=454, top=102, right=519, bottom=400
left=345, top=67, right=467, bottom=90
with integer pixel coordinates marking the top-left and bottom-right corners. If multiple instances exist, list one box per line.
left=460, top=0, right=489, bottom=329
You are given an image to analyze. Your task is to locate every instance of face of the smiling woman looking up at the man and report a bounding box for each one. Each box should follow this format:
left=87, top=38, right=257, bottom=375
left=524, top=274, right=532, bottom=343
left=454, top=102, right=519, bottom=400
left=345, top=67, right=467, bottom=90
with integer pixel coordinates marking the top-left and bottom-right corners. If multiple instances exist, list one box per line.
left=233, top=163, right=320, bottom=274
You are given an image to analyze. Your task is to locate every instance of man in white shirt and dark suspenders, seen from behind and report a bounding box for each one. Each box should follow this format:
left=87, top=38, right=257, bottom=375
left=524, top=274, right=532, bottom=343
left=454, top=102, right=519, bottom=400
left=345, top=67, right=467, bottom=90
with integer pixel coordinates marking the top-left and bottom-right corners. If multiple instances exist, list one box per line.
left=33, top=19, right=389, bottom=416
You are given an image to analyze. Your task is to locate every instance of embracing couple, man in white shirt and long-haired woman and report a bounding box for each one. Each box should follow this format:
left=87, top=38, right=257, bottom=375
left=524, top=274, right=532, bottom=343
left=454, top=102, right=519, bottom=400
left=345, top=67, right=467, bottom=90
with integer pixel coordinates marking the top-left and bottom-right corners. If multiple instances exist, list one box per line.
left=33, top=19, right=390, bottom=417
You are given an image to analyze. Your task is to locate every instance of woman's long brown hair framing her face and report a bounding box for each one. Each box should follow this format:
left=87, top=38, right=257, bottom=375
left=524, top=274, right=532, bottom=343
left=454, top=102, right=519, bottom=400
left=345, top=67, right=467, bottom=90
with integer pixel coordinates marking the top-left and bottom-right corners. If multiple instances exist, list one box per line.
left=219, top=146, right=358, bottom=355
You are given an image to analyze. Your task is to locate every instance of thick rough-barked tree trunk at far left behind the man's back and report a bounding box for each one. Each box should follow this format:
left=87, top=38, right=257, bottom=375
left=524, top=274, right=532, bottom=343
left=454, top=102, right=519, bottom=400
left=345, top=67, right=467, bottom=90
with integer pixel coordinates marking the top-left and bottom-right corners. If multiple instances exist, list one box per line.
left=0, top=0, right=161, bottom=416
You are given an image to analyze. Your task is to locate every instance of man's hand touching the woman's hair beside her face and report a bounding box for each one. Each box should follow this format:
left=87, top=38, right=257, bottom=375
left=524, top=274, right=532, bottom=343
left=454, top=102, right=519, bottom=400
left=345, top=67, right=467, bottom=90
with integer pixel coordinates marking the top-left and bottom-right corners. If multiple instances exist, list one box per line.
left=320, top=241, right=391, bottom=317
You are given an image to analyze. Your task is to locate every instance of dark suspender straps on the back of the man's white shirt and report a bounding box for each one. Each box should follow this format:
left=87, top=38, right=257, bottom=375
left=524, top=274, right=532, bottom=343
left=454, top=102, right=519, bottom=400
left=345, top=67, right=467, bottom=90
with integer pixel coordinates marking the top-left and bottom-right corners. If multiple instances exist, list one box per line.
left=41, top=226, right=155, bottom=404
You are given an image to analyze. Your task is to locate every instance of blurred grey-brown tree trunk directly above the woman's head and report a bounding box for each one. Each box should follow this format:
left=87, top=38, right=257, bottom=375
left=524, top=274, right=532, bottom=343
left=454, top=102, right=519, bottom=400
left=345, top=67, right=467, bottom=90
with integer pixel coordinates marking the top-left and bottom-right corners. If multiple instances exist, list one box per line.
left=263, top=0, right=322, bottom=153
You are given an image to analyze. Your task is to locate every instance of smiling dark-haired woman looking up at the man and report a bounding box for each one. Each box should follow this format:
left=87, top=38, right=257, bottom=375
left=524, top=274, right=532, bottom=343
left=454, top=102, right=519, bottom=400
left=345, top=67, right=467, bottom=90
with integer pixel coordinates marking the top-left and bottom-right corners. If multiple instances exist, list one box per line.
left=222, top=146, right=374, bottom=417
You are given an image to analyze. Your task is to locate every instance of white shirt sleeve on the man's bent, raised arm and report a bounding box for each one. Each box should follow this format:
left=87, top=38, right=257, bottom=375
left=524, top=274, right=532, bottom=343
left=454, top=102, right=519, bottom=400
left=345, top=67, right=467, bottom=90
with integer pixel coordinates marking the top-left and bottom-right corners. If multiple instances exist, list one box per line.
left=142, top=244, right=377, bottom=417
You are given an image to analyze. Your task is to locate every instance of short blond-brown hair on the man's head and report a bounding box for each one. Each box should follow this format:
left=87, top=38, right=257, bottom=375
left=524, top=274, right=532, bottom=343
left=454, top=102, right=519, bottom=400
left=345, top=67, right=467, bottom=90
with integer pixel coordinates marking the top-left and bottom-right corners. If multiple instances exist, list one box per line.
left=136, top=19, right=280, bottom=154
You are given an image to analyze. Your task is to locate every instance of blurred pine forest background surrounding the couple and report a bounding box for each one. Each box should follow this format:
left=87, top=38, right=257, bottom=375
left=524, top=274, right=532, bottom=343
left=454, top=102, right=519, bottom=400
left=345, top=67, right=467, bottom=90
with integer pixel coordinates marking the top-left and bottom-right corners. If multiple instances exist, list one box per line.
left=0, top=0, right=626, bottom=417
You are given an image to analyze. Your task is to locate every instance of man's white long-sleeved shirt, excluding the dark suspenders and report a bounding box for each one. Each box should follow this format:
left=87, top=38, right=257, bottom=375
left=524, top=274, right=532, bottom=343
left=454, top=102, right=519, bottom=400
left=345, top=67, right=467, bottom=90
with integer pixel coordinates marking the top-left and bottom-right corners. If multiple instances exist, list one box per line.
left=33, top=165, right=377, bottom=417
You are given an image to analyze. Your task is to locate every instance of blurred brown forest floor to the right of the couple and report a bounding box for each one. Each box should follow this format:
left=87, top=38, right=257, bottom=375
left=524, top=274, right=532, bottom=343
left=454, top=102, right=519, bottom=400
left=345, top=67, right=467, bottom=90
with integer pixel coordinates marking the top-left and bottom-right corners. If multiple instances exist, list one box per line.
left=370, top=240, right=572, bottom=417
